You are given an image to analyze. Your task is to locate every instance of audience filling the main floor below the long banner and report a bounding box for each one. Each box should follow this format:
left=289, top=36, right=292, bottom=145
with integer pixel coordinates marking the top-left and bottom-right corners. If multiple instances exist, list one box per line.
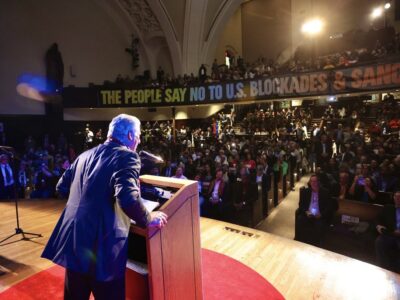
left=0, top=95, right=400, bottom=270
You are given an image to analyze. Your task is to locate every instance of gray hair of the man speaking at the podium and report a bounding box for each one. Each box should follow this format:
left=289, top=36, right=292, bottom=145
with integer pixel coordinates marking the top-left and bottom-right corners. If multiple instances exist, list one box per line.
left=107, top=114, right=140, bottom=145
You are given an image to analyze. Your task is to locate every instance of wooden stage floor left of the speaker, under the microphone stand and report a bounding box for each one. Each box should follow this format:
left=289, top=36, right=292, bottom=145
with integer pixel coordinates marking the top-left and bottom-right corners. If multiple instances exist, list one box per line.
left=0, top=199, right=65, bottom=292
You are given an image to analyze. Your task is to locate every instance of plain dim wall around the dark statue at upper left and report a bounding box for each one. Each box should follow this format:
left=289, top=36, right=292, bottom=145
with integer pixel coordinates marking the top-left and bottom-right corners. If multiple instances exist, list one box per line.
left=0, top=0, right=148, bottom=115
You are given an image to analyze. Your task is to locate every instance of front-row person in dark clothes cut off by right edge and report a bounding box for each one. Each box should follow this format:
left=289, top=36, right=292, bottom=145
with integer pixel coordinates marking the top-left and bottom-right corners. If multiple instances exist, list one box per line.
left=375, top=191, right=400, bottom=273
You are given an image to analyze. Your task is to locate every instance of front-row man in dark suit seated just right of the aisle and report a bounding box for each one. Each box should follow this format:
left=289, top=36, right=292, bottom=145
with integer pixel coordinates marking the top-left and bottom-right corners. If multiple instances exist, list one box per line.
left=295, top=175, right=334, bottom=246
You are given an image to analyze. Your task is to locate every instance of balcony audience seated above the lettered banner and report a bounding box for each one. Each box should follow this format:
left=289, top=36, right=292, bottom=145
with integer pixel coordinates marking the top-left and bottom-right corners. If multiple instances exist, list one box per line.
left=105, top=29, right=400, bottom=87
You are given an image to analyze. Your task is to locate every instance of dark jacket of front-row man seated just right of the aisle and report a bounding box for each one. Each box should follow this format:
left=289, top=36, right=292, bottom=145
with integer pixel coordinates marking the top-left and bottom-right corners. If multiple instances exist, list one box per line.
left=298, top=187, right=334, bottom=222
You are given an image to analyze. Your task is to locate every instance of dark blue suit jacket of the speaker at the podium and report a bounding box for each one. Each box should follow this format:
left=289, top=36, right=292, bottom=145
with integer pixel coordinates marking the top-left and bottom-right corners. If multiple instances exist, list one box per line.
left=42, top=142, right=150, bottom=281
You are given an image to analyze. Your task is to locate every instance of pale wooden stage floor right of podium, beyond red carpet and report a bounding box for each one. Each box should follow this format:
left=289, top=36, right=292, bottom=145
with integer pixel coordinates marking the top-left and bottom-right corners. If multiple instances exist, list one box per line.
left=200, top=218, right=400, bottom=300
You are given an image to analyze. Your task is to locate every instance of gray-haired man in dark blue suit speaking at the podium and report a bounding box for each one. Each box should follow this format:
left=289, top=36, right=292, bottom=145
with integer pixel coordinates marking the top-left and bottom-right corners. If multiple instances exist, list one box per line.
left=42, top=114, right=167, bottom=300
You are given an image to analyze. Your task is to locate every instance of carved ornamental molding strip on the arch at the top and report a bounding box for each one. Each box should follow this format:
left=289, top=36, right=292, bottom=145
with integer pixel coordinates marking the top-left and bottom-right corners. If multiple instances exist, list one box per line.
left=117, top=0, right=161, bottom=33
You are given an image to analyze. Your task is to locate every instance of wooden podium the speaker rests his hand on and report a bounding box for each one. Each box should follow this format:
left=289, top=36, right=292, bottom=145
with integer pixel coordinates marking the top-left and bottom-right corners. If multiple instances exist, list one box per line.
left=126, top=175, right=202, bottom=300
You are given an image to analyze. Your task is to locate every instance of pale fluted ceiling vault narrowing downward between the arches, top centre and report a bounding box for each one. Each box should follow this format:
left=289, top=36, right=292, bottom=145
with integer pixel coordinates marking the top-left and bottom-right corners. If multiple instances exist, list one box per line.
left=98, top=0, right=245, bottom=75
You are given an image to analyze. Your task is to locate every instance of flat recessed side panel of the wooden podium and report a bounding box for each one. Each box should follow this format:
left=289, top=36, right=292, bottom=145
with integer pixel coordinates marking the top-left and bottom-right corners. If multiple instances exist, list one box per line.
left=161, top=201, right=196, bottom=300
